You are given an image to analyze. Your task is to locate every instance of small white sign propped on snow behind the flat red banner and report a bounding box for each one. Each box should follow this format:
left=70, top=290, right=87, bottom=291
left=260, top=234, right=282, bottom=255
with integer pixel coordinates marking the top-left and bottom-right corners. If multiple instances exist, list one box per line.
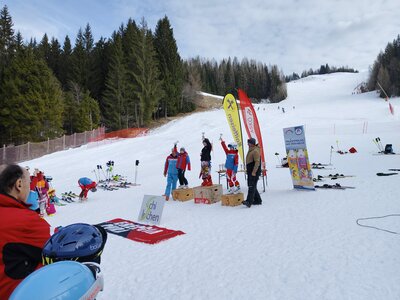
left=138, top=195, right=165, bottom=225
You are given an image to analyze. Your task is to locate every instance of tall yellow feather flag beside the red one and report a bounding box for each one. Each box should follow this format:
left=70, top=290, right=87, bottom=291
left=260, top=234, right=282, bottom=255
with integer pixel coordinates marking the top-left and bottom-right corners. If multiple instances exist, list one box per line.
left=223, top=94, right=245, bottom=164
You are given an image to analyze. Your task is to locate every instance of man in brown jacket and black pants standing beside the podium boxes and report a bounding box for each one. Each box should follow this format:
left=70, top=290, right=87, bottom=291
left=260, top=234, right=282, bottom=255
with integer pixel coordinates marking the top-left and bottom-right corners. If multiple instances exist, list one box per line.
left=242, top=138, right=262, bottom=207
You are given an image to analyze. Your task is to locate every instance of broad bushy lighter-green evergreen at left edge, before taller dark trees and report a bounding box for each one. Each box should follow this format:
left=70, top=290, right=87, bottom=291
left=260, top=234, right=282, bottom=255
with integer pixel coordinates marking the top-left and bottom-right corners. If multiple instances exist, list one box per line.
left=0, top=49, right=63, bottom=143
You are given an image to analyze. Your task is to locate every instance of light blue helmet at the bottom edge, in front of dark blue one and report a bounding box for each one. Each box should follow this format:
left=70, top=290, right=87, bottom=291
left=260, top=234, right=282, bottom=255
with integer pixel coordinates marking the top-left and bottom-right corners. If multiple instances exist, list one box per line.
left=10, top=261, right=104, bottom=300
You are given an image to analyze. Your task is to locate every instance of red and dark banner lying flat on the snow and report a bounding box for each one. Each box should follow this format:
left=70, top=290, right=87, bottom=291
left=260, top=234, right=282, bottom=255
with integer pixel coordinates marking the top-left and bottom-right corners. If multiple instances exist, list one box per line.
left=98, top=218, right=185, bottom=244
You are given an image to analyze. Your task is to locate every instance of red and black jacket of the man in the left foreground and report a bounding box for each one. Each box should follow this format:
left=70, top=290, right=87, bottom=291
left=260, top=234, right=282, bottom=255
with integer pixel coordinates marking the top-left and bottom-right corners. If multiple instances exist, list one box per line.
left=0, top=194, right=50, bottom=299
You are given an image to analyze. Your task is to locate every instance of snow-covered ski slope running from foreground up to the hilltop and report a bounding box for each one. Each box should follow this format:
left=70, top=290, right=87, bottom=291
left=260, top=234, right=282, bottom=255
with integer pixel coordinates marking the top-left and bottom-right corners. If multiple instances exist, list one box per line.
left=21, top=73, right=400, bottom=300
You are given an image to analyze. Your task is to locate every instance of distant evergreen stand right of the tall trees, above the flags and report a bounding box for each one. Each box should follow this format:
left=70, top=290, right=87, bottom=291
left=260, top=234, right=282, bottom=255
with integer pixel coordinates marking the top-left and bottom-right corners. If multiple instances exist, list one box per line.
left=184, top=57, right=287, bottom=102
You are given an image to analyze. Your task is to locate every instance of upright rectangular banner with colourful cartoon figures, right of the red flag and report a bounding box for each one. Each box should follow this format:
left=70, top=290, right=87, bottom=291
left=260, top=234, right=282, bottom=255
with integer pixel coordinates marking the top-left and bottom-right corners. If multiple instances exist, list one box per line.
left=283, top=126, right=315, bottom=190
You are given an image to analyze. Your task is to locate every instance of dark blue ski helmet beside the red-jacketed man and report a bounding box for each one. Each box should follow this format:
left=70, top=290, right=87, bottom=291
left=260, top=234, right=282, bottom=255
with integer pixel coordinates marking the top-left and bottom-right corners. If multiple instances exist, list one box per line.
left=42, top=223, right=107, bottom=265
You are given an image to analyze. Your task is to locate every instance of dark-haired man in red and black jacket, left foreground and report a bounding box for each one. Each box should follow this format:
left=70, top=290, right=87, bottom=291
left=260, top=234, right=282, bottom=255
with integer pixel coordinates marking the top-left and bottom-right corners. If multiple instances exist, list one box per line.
left=0, top=165, right=50, bottom=299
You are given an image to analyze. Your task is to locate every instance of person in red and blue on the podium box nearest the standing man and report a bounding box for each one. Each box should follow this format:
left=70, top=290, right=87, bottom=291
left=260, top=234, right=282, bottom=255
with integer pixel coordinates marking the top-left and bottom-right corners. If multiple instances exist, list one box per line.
left=221, top=138, right=240, bottom=194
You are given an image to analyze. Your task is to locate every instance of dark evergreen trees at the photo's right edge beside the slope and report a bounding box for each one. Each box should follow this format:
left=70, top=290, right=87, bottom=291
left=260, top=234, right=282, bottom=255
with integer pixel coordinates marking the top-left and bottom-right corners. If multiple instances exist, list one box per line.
left=367, top=35, right=400, bottom=98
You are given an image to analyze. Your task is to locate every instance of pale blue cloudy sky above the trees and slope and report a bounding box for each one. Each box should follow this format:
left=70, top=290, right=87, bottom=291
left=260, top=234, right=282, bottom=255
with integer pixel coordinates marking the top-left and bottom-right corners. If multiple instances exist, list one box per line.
left=0, top=0, right=400, bottom=75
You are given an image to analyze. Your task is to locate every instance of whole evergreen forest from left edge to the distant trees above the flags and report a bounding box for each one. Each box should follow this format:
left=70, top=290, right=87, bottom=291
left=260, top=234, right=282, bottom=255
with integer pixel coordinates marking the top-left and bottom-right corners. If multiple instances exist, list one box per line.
left=0, top=6, right=286, bottom=145
